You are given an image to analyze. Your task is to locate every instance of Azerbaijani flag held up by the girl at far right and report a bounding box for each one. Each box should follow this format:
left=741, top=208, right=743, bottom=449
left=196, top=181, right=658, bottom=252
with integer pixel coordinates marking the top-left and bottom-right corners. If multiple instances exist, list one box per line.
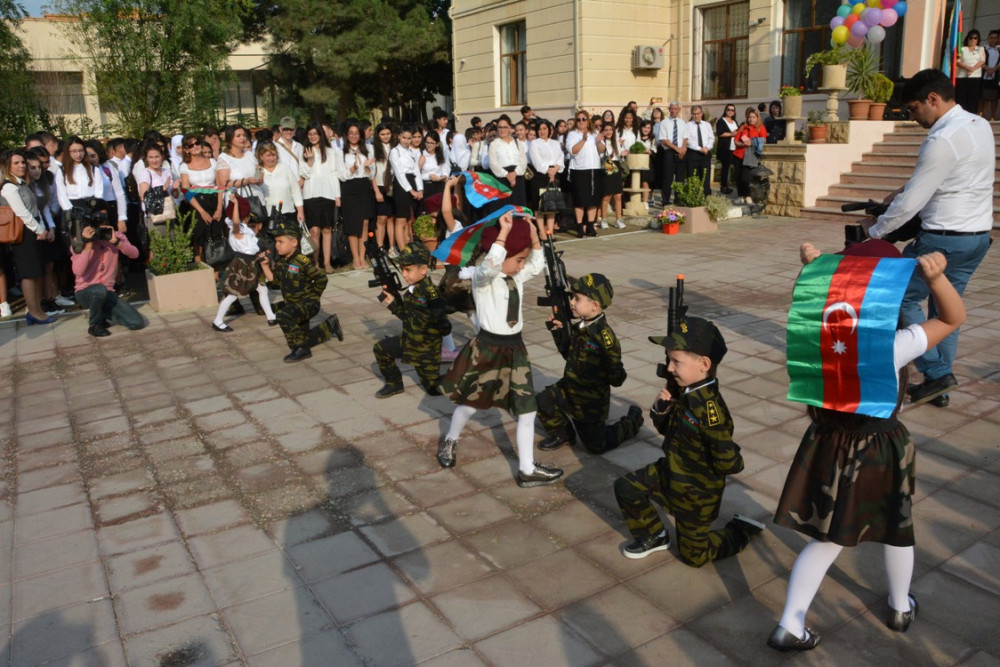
left=786, top=255, right=917, bottom=417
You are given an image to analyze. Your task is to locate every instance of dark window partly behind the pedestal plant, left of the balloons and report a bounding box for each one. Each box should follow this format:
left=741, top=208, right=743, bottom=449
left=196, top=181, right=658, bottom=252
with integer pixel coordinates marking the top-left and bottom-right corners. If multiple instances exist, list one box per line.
left=781, top=0, right=841, bottom=92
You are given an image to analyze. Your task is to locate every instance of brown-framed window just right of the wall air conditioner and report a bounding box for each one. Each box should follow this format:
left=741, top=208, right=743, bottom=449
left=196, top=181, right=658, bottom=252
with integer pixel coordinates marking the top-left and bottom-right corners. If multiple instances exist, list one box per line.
left=701, top=2, right=750, bottom=100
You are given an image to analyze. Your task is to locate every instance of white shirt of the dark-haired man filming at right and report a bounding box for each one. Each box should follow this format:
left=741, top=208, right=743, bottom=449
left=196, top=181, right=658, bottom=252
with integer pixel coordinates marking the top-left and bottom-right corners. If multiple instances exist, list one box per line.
left=868, top=104, right=996, bottom=239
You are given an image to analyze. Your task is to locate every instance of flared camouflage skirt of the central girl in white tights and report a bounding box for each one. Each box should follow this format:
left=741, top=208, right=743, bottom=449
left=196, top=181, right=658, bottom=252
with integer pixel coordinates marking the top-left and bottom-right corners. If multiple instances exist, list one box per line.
left=441, top=330, right=538, bottom=416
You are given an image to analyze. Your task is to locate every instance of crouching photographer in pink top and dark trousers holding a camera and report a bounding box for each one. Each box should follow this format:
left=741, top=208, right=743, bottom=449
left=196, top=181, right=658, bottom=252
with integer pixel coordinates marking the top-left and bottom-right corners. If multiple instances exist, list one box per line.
left=71, top=218, right=146, bottom=338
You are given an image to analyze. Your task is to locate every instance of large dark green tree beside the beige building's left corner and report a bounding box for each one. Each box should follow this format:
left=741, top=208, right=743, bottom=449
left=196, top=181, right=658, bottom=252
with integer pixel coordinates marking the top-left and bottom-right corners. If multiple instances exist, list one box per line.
left=268, top=0, right=451, bottom=119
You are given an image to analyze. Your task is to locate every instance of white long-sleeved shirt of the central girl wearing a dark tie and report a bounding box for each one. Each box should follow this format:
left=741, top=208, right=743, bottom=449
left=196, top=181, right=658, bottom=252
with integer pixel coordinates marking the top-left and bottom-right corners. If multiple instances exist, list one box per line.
left=472, top=243, right=545, bottom=336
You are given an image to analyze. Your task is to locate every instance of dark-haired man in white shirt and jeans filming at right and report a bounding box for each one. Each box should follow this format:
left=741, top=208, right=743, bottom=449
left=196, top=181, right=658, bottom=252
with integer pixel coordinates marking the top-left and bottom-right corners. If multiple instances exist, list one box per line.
left=864, top=69, right=996, bottom=407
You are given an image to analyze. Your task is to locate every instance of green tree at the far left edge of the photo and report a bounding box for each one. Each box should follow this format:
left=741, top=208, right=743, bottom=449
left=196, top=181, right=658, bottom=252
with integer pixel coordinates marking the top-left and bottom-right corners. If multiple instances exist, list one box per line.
left=0, top=0, right=48, bottom=146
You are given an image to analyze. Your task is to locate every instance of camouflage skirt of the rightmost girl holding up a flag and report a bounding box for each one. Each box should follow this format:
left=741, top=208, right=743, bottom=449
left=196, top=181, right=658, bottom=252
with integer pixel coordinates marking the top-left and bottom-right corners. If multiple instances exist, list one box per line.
left=774, top=418, right=916, bottom=547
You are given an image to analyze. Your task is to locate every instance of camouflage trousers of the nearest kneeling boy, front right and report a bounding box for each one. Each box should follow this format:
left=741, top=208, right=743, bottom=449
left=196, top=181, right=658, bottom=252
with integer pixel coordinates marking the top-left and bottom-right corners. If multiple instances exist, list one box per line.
left=615, top=462, right=749, bottom=567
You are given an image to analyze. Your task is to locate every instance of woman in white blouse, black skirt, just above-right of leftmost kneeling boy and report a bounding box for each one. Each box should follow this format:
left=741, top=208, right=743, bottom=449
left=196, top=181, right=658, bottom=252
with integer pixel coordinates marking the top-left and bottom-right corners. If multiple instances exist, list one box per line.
left=300, top=123, right=340, bottom=273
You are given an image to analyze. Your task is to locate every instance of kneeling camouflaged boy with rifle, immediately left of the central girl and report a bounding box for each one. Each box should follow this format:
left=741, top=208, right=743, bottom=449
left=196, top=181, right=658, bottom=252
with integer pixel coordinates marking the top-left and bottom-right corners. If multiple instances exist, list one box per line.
left=374, top=241, right=451, bottom=398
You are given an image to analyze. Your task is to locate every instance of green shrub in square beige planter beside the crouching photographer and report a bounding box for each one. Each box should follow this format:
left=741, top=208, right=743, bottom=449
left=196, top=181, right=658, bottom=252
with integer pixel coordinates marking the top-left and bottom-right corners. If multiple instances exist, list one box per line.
left=146, top=212, right=219, bottom=313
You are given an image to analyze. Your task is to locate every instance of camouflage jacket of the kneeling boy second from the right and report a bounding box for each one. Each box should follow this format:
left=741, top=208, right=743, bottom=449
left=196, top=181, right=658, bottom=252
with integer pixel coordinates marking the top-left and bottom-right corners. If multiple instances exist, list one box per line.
left=552, top=314, right=628, bottom=422
